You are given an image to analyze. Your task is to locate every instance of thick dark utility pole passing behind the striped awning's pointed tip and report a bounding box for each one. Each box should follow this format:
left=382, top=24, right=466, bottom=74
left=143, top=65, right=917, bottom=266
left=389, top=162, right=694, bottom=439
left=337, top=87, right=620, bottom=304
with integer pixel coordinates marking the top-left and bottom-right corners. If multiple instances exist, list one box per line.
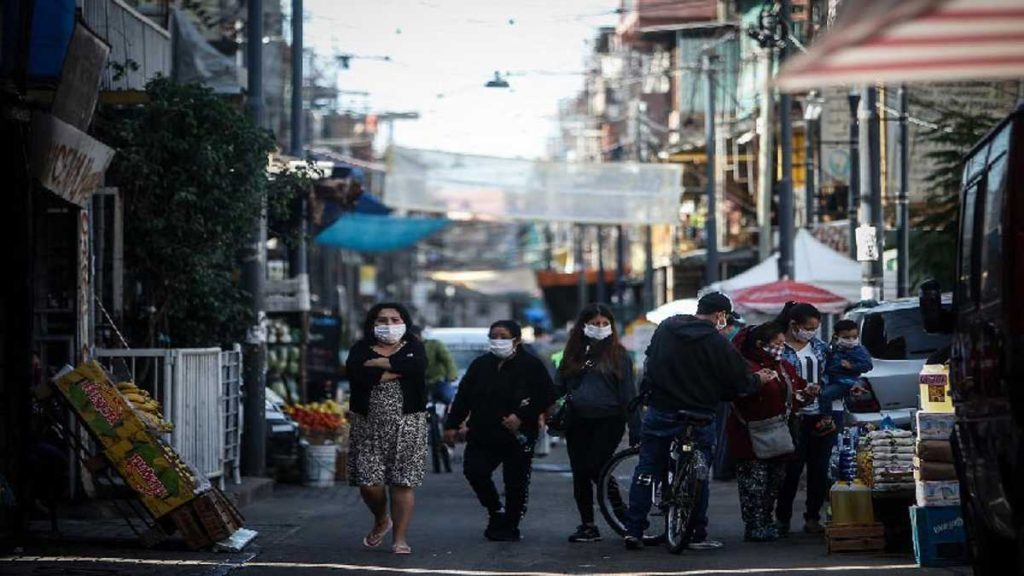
left=778, top=0, right=797, bottom=280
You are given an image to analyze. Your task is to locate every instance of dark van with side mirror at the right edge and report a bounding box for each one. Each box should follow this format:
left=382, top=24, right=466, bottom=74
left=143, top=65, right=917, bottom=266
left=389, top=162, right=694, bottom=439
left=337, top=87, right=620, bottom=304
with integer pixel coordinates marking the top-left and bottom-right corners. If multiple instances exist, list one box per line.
left=921, top=104, right=1024, bottom=575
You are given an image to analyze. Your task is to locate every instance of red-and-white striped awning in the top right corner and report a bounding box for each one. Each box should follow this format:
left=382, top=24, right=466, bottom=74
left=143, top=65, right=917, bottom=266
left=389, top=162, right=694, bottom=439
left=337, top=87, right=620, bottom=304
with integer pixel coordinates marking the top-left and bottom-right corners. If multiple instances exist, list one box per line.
left=776, top=0, right=1024, bottom=91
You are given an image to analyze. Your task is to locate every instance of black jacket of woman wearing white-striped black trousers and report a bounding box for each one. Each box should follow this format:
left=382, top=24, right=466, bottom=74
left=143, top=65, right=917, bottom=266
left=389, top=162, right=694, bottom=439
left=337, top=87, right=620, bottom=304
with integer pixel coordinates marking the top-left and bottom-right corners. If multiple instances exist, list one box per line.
left=444, top=346, right=555, bottom=446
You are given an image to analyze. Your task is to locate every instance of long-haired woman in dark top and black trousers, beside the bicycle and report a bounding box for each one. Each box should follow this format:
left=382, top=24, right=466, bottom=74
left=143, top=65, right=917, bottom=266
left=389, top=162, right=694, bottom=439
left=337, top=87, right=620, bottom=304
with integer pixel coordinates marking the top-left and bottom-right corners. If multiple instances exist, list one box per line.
left=555, top=304, right=639, bottom=542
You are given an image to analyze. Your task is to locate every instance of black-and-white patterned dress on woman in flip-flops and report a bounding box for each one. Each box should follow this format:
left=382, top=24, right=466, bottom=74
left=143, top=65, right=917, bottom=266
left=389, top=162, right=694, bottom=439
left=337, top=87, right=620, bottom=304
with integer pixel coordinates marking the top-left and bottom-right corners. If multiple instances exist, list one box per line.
left=348, top=380, right=427, bottom=487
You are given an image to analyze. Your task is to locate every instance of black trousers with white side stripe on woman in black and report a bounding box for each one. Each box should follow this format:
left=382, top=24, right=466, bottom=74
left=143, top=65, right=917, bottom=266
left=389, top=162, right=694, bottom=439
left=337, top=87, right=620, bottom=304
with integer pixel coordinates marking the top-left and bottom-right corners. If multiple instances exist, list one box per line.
left=463, top=441, right=534, bottom=528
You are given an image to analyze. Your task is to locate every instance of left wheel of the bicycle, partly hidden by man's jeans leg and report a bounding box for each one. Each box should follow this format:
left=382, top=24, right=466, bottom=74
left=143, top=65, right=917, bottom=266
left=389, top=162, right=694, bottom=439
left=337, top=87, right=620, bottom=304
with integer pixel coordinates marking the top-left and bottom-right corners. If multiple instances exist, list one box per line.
left=597, top=447, right=666, bottom=546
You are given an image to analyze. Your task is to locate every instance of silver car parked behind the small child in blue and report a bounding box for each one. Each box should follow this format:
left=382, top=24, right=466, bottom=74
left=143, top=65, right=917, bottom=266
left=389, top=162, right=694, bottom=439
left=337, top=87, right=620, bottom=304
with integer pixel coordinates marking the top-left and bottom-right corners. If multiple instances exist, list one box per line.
left=846, top=297, right=951, bottom=428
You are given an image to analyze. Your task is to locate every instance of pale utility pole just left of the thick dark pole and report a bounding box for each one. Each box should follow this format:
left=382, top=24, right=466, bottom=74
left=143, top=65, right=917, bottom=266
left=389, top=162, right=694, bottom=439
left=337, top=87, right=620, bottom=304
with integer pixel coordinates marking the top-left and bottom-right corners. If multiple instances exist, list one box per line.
left=757, top=46, right=775, bottom=261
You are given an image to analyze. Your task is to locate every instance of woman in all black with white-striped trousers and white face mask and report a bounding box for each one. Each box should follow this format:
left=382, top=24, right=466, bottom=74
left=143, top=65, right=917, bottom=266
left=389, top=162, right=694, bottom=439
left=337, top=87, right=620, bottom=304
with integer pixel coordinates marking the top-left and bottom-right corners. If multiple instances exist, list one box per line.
left=444, top=320, right=555, bottom=542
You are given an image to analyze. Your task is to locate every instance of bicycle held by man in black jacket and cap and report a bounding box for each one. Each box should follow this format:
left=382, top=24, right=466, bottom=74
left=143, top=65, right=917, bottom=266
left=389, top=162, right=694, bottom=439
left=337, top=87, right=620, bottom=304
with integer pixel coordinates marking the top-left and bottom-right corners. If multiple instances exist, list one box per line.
left=597, top=410, right=714, bottom=554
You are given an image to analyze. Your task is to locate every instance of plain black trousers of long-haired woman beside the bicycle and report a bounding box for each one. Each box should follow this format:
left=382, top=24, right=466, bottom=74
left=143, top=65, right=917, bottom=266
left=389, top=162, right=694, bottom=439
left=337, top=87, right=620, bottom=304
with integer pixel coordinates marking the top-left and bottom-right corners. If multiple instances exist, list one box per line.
left=565, top=417, right=626, bottom=524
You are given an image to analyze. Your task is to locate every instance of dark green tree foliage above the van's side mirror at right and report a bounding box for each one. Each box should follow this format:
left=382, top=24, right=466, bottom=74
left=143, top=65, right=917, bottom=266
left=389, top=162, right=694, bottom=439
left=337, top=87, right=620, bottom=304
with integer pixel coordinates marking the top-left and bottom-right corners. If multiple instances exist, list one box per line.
left=910, top=99, right=998, bottom=287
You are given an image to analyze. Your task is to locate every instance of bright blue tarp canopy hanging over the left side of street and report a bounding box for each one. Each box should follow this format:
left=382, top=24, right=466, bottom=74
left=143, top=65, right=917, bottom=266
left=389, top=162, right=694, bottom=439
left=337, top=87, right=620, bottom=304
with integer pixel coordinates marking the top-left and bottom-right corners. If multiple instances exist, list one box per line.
left=316, top=213, right=449, bottom=252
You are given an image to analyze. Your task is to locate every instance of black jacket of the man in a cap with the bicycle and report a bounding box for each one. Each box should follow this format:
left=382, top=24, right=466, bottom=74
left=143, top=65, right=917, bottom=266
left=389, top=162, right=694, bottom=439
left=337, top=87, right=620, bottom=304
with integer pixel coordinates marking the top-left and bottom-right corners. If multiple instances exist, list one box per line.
left=645, top=316, right=760, bottom=414
